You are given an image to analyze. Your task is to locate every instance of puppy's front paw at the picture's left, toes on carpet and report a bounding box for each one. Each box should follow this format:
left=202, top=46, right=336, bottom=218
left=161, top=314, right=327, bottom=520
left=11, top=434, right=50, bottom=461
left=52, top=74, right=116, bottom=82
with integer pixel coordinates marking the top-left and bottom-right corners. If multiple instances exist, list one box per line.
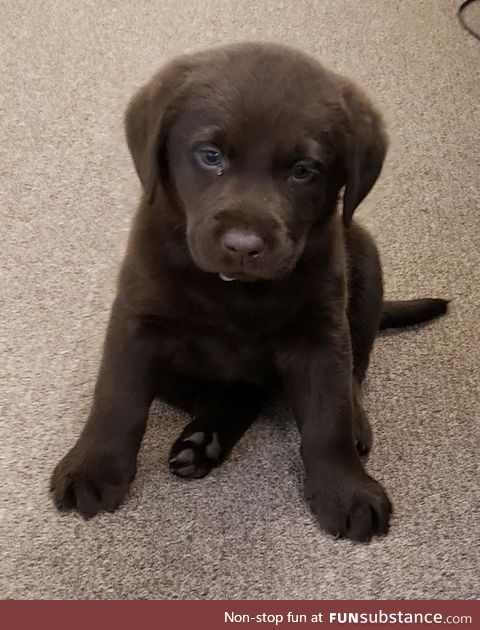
left=50, top=439, right=136, bottom=518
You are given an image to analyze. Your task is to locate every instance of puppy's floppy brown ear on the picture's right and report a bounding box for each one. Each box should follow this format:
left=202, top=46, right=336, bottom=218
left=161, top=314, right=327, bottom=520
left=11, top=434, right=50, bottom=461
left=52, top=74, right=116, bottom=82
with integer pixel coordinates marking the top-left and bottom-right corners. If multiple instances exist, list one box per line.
left=342, top=84, right=388, bottom=227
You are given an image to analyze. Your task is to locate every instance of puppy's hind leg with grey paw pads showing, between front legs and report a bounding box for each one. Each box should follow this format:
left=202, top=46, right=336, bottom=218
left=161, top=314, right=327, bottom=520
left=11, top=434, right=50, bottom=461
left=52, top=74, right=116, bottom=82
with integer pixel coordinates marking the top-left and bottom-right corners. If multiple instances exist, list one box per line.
left=170, top=383, right=265, bottom=478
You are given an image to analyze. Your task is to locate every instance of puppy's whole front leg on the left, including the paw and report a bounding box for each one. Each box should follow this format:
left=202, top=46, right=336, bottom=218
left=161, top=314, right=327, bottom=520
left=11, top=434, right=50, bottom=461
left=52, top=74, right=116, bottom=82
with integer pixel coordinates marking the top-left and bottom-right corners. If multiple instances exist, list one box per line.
left=51, top=304, right=154, bottom=518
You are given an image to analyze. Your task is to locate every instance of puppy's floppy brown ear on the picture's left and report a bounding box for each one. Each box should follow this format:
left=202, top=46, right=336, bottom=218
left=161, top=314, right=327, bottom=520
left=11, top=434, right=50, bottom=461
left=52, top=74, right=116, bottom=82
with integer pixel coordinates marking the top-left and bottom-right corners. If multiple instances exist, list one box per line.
left=125, top=58, right=194, bottom=203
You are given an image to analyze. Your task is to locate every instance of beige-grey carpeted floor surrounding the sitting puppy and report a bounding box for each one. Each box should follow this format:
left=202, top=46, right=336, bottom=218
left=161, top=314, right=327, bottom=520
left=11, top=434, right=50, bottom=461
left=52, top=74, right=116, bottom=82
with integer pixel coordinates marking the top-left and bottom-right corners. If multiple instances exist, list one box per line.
left=0, top=0, right=480, bottom=599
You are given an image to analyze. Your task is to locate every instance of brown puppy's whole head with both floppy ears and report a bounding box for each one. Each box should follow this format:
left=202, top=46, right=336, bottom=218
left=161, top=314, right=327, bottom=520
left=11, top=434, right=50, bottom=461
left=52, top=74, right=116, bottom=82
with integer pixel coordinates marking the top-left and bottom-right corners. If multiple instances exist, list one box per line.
left=126, top=44, right=387, bottom=280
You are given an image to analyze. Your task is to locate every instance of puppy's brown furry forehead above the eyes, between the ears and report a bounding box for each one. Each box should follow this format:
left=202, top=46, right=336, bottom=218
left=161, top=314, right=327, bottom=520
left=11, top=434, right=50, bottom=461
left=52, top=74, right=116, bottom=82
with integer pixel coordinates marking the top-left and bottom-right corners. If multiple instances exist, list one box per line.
left=171, top=64, right=339, bottom=160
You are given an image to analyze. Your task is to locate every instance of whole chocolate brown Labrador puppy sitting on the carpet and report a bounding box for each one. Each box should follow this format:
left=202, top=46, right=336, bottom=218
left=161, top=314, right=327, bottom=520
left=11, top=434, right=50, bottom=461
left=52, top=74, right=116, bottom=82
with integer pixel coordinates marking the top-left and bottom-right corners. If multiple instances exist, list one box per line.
left=51, top=44, right=446, bottom=541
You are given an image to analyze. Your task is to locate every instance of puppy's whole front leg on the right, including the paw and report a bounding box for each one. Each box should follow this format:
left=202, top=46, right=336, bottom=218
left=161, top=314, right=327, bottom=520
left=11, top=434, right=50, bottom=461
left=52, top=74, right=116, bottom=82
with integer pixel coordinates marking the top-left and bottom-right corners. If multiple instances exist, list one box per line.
left=278, top=321, right=390, bottom=541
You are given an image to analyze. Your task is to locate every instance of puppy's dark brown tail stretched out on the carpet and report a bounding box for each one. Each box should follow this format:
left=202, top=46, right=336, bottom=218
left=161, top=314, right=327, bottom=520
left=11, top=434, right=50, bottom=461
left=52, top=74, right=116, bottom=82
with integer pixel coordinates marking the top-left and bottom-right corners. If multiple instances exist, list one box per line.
left=380, top=298, right=449, bottom=330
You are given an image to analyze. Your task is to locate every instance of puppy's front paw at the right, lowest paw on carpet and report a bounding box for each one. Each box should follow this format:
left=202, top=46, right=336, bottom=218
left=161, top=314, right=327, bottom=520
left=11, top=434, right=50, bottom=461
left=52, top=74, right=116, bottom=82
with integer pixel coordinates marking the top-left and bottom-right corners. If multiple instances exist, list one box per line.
left=305, top=465, right=392, bottom=542
